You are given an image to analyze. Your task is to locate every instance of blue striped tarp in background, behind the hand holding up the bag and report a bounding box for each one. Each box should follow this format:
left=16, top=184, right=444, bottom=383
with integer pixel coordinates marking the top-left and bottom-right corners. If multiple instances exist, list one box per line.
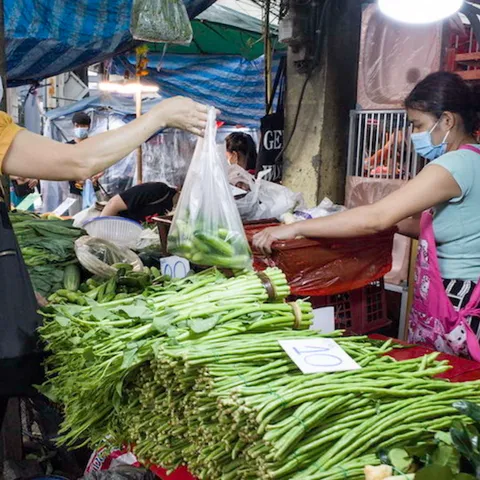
left=112, top=54, right=281, bottom=128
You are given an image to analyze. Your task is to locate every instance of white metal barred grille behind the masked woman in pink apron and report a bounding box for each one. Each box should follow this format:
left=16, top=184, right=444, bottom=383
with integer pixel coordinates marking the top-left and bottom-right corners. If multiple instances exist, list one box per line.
left=347, top=110, right=425, bottom=180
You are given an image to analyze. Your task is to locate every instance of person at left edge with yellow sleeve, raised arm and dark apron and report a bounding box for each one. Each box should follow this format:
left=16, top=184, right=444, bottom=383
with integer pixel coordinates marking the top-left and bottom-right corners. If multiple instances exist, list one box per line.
left=0, top=97, right=207, bottom=432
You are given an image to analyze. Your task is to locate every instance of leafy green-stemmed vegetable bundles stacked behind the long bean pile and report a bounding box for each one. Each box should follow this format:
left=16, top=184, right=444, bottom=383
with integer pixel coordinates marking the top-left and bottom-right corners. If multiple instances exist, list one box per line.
left=40, top=269, right=313, bottom=445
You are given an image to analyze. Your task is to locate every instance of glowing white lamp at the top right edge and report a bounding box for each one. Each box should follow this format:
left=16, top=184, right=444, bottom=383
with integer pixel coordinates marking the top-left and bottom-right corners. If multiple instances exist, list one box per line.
left=378, top=0, right=464, bottom=24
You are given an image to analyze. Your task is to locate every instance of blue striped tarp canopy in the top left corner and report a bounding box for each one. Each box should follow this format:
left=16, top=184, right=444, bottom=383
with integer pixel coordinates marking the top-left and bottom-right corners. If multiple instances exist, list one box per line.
left=4, top=0, right=214, bottom=87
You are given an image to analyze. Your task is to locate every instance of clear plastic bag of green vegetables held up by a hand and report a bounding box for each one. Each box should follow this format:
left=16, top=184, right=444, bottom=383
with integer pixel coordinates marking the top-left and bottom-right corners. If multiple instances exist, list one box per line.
left=168, top=108, right=252, bottom=269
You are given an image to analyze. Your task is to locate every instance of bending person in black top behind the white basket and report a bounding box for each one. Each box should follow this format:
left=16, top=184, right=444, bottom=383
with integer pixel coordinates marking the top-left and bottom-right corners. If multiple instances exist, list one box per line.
left=102, top=182, right=178, bottom=223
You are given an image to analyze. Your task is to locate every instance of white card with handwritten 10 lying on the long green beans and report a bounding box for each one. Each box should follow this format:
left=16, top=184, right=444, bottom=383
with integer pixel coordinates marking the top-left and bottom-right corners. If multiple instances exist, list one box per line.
left=278, top=338, right=361, bottom=373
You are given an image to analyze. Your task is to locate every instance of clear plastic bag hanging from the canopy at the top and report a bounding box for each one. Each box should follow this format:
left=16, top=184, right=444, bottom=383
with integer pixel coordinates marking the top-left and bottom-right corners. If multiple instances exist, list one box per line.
left=130, top=0, right=193, bottom=45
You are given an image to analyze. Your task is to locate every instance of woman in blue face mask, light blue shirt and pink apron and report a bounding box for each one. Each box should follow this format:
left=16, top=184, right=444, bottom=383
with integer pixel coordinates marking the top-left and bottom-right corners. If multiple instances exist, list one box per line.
left=254, top=72, right=480, bottom=361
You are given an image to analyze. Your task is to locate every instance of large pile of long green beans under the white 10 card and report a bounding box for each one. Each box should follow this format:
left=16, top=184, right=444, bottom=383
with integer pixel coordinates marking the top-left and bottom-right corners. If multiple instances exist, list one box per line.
left=118, top=331, right=480, bottom=480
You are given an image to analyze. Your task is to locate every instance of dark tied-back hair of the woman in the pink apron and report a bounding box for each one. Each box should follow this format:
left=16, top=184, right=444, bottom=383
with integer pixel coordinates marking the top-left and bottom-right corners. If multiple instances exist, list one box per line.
left=405, top=72, right=480, bottom=134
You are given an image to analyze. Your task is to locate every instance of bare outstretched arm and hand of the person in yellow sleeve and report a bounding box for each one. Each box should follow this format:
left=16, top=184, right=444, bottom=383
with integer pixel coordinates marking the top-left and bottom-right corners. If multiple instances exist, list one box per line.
left=2, top=97, right=207, bottom=180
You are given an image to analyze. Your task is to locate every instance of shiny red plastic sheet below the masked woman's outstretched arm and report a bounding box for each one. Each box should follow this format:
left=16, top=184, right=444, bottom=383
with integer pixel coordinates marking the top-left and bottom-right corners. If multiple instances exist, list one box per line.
left=245, top=223, right=396, bottom=296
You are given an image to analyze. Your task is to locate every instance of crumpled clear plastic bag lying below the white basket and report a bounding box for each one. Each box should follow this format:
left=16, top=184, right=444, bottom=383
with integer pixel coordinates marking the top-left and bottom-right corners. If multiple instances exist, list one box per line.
left=75, top=235, right=143, bottom=278
